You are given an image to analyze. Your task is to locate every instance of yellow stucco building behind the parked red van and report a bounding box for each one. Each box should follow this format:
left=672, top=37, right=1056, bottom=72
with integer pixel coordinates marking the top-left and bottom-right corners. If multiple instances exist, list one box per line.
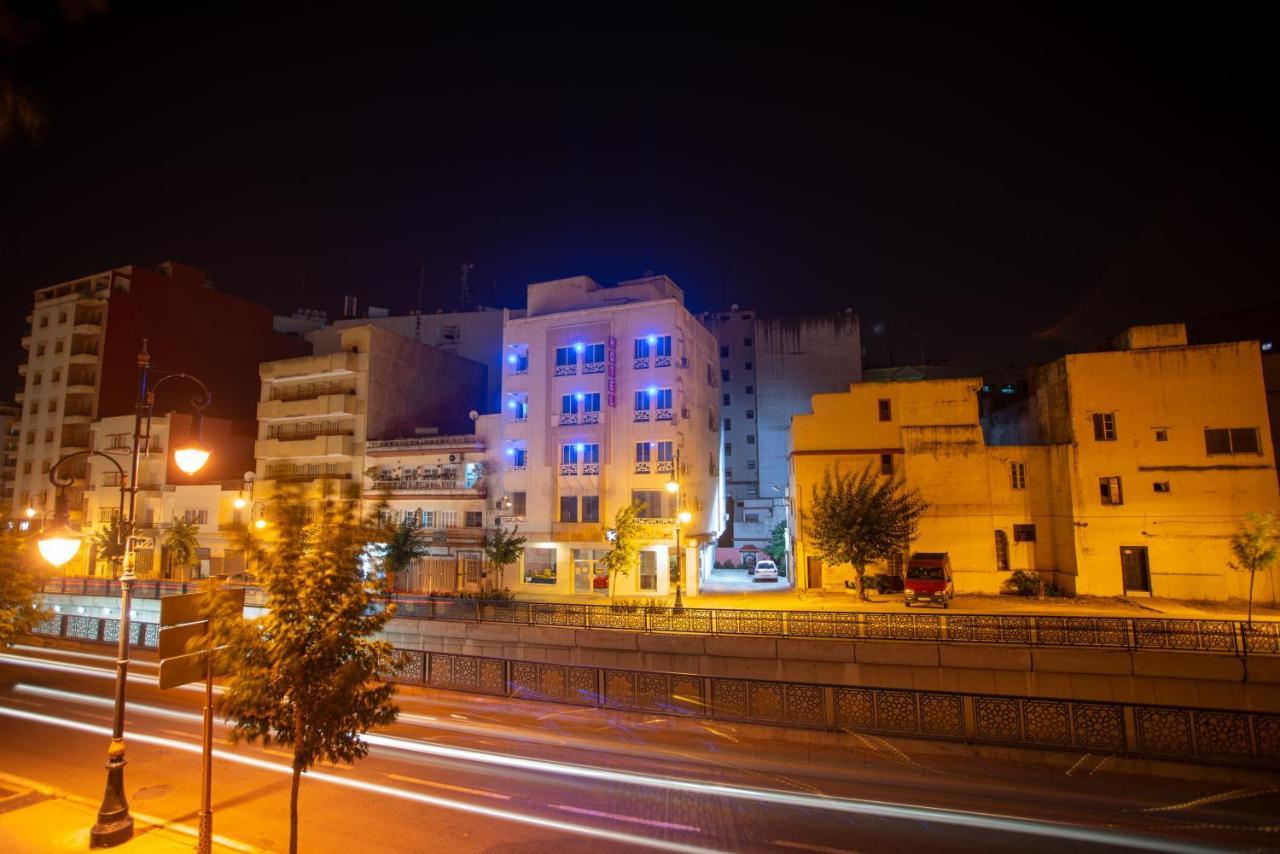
left=788, top=324, right=1280, bottom=602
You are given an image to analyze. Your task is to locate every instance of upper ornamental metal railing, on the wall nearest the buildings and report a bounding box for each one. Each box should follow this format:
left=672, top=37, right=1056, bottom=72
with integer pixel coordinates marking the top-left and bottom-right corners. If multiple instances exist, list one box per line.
left=45, top=578, right=1280, bottom=656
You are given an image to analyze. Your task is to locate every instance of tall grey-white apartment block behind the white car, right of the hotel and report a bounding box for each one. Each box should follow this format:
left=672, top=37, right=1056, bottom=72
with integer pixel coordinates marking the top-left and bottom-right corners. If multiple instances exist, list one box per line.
left=703, top=306, right=863, bottom=561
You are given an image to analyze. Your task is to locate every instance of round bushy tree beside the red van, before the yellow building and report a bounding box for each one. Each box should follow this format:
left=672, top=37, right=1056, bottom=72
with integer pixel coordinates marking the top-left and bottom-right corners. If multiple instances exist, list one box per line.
left=808, top=463, right=928, bottom=602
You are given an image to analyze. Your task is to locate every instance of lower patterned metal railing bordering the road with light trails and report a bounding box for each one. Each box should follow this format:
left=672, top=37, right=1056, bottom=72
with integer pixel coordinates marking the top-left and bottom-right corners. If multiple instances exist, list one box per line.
left=27, top=615, right=1280, bottom=768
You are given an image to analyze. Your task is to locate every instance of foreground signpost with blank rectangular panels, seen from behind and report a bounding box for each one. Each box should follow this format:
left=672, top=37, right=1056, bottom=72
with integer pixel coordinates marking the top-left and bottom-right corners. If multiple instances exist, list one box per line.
left=160, top=577, right=244, bottom=854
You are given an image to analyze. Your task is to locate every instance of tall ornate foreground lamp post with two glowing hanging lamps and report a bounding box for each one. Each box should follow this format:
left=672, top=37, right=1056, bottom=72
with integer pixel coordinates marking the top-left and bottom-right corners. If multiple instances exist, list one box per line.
left=37, top=338, right=212, bottom=848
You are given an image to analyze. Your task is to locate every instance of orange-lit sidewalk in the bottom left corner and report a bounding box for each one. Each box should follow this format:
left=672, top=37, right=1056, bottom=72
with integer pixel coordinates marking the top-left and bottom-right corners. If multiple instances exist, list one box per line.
left=0, top=772, right=262, bottom=854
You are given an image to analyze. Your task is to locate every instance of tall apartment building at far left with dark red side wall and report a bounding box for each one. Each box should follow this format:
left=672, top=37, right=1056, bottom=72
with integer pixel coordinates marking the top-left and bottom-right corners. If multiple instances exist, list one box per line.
left=12, top=261, right=306, bottom=521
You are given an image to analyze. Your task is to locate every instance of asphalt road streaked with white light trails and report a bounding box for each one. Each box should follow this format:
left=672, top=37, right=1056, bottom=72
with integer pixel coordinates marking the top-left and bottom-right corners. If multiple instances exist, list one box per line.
left=0, top=647, right=1280, bottom=854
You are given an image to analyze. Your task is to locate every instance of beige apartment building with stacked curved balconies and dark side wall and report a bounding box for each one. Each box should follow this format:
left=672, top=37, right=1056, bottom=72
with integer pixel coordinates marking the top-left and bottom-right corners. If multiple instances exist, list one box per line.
left=255, top=324, right=486, bottom=512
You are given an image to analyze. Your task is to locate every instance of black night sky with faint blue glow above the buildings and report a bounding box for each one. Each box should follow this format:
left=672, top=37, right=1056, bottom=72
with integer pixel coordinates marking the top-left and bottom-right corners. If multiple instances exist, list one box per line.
left=0, top=1, right=1280, bottom=402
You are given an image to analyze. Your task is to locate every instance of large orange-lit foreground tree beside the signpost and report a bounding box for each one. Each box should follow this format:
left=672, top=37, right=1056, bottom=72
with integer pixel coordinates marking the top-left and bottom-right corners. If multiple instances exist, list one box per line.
left=207, top=495, right=398, bottom=854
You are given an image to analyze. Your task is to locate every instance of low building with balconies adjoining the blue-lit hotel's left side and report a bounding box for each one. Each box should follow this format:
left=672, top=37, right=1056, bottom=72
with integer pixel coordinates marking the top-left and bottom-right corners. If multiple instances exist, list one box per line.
left=364, top=416, right=499, bottom=593
